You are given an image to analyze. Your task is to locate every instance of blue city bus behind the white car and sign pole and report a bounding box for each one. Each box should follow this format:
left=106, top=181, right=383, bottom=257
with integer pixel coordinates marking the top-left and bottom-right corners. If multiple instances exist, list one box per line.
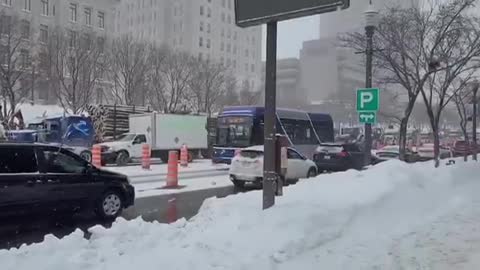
left=212, top=106, right=334, bottom=164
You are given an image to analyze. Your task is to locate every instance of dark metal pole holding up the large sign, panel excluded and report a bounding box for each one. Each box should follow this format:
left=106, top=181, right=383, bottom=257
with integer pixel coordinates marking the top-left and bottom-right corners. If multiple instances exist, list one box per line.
left=263, top=22, right=278, bottom=209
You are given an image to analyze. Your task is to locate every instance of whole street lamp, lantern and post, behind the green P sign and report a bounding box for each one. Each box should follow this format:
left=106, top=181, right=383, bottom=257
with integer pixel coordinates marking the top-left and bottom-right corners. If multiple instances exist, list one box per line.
left=364, top=0, right=378, bottom=165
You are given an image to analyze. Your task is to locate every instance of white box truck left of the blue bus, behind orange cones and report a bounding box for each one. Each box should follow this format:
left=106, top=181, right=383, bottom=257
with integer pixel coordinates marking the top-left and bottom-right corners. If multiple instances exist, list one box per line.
left=101, top=112, right=208, bottom=166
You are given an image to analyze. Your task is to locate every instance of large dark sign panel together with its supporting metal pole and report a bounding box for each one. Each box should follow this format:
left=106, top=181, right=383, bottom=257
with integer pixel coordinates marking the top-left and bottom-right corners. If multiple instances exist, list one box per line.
left=235, top=0, right=350, bottom=209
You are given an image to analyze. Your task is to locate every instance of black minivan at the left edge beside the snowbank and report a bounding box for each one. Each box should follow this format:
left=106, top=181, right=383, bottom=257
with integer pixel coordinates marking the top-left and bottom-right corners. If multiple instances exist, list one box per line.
left=0, top=143, right=135, bottom=219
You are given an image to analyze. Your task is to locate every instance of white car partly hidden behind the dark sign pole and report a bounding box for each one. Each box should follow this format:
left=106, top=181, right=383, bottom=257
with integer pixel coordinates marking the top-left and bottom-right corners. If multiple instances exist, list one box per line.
left=229, top=146, right=317, bottom=187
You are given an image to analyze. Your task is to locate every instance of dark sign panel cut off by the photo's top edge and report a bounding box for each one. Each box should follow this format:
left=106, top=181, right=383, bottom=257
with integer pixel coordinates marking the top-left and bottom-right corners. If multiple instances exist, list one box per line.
left=235, top=0, right=350, bottom=27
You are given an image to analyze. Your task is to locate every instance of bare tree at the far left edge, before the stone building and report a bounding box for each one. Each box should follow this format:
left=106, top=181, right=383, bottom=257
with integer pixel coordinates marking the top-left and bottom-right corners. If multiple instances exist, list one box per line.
left=0, top=10, right=36, bottom=124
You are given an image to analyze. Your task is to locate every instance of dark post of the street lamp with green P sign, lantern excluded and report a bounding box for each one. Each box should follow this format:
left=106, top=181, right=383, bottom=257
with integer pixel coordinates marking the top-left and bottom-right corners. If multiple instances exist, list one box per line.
left=365, top=26, right=375, bottom=166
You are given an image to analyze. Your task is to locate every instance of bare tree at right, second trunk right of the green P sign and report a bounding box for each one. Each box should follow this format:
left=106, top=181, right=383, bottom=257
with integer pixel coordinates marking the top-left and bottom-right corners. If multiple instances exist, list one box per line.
left=421, top=0, right=480, bottom=166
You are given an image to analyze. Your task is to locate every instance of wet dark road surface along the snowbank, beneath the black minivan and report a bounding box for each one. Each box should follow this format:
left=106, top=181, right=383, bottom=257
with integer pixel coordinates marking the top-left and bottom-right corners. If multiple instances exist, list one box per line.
left=0, top=186, right=244, bottom=249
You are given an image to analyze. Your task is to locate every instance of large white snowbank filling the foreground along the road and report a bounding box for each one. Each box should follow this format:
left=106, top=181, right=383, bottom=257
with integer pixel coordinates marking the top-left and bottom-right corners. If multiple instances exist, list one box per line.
left=0, top=161, right=480, bottom=270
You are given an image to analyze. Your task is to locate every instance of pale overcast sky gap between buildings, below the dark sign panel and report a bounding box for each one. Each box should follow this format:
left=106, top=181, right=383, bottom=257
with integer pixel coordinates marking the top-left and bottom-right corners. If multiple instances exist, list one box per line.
left=263, top=16, right=319, bottom=59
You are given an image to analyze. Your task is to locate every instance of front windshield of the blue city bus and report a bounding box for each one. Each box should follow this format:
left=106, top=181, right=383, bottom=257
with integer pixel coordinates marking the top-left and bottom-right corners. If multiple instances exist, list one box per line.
left=215, top=116, right=253, bottom=147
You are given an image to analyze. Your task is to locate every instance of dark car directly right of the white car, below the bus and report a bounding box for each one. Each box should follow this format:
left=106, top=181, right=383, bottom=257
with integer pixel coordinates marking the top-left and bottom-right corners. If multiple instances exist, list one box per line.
left=313, top=143, right=365, bottom=172
